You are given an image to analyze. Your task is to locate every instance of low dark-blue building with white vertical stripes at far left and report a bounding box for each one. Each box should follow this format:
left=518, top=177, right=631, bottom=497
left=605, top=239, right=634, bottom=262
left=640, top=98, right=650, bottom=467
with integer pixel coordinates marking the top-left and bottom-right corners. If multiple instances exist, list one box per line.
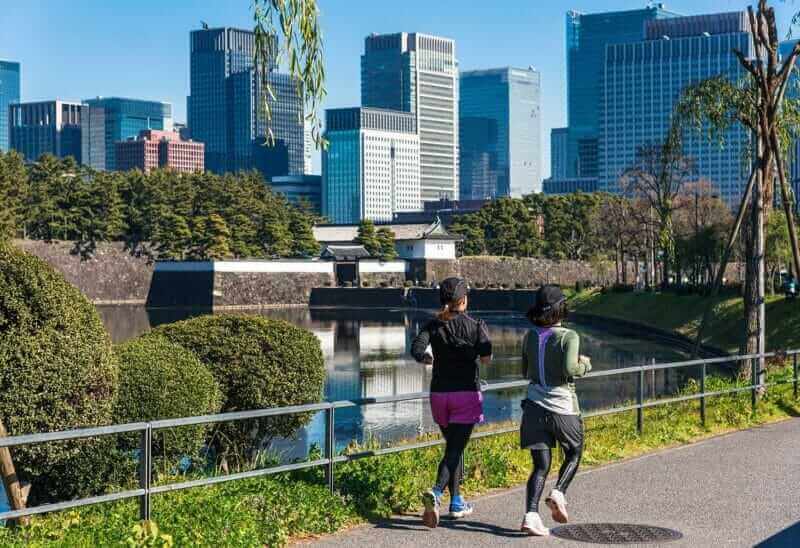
left=9, top=99, right=84, bottom=163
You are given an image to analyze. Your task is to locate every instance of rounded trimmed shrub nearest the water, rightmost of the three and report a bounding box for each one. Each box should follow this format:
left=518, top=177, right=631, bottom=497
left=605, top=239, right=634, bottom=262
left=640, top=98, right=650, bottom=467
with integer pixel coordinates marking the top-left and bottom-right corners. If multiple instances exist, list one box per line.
left=146, top=315, right=325, bottom=457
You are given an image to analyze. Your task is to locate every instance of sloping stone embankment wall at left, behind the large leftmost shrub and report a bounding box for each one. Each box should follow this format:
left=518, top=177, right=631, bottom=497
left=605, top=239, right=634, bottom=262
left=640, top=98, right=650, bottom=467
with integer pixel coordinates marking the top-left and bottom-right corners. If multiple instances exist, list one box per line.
left=14, top=240, right=153, bottom=304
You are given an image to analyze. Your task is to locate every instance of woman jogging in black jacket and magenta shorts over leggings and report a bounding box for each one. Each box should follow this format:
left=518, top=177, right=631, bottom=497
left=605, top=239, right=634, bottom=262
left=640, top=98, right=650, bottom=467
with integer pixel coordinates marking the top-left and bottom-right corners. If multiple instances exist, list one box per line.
left=411, top=278, right=492, bottom=528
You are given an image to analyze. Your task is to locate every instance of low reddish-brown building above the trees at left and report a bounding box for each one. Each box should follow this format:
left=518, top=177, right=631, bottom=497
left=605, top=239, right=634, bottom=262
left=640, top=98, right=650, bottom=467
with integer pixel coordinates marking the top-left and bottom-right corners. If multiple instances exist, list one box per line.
left=114, top=129, right=204, bottom=173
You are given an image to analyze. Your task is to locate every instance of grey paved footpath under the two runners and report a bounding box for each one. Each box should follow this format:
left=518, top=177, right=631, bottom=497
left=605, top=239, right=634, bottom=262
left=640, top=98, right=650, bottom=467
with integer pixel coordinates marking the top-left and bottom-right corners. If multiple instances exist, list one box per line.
left=314, top=419, right=800, bottom=548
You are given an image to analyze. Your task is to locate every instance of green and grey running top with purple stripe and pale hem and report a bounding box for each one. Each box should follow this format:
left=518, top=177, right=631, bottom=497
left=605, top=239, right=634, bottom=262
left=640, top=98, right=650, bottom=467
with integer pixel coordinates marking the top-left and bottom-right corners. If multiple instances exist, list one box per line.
left=522, top=327, right=592, bottom=415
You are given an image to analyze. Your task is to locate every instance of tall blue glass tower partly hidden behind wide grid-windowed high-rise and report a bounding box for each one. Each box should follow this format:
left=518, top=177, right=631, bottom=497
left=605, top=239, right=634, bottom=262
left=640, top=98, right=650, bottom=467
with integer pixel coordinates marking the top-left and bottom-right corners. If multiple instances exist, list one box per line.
left=565, top=3, right=676, bottom=178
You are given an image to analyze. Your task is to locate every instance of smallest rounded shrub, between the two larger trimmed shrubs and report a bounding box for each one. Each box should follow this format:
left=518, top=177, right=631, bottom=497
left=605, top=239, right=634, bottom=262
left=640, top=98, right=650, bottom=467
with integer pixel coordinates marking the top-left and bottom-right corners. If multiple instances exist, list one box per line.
left=114, top=336, right=222, bottom=459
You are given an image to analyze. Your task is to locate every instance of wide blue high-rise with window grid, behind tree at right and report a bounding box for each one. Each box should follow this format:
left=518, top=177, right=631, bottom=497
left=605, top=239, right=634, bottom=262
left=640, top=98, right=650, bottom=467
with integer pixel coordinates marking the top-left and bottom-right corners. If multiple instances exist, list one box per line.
left=599, top=12, right=754, bottom=206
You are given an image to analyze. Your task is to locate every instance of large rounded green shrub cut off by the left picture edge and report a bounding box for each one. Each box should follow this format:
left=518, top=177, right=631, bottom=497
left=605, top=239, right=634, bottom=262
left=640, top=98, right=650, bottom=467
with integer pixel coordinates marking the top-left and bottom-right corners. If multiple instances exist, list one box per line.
left=0, top=244, right=117, bottom=504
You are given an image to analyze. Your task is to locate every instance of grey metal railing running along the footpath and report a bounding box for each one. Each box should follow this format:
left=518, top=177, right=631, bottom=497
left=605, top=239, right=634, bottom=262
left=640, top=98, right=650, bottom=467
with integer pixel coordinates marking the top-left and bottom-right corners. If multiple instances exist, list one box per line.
left=0, top=350, right=800, bottom=521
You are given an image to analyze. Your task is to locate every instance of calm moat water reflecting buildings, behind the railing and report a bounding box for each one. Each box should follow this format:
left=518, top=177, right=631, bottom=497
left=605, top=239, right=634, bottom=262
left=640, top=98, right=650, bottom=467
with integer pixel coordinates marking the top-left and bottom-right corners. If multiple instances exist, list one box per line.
left=100, top=307, right=685, bottom=458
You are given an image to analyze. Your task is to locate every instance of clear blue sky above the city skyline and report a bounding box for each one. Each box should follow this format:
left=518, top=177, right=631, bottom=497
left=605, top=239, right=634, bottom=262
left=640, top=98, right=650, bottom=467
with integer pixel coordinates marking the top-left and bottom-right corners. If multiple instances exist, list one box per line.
left=0, top=0, right=800, bottom=176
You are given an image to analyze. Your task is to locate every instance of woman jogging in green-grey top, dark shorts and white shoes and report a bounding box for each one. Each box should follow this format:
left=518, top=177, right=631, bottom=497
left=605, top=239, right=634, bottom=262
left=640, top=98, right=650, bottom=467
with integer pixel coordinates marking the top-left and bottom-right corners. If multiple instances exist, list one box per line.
left=520, top=285, right=592, bottom=536
